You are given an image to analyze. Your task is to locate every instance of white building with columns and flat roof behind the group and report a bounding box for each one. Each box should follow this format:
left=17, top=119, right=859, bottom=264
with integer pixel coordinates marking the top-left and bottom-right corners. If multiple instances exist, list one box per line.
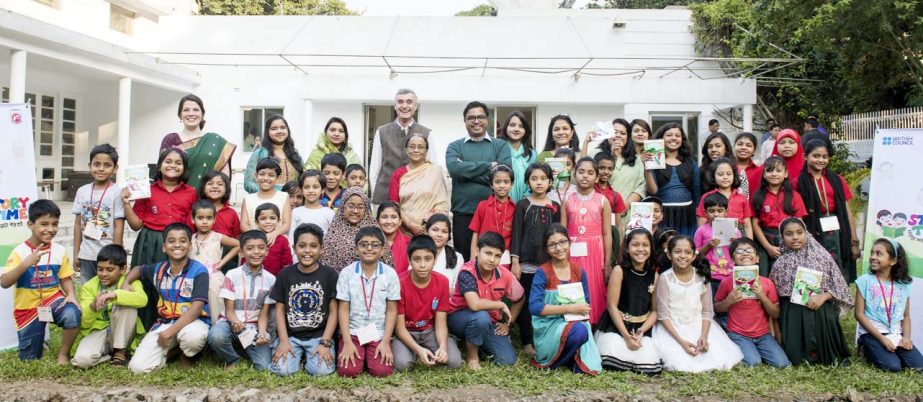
left=0, top=0, right=775, bottom=198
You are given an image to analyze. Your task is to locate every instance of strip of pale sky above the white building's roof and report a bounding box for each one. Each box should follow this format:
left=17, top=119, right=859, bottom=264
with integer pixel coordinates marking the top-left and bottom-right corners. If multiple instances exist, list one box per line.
left=345, top=0, right=588, bottom=16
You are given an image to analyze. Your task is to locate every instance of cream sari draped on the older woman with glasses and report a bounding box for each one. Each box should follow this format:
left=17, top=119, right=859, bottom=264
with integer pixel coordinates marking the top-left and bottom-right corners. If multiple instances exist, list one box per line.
left=398, top=162, right=449, bottom=229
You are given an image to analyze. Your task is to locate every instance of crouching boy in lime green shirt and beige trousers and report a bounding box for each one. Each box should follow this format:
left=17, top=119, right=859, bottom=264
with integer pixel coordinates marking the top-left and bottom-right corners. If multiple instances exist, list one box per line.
left=71, top=244, right=147, bottom=369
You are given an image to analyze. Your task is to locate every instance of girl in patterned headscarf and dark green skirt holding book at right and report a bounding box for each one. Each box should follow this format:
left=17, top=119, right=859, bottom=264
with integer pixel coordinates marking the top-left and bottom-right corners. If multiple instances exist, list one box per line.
left=769, top=218, right=853, bottom=365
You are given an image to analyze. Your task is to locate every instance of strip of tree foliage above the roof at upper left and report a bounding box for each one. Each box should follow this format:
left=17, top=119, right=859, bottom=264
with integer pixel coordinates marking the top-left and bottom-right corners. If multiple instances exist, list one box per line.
left=198, top=0, right=359, bottom=15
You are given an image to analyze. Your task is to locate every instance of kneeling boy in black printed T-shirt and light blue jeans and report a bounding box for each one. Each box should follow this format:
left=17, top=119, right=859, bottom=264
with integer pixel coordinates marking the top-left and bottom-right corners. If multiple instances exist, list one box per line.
left=269, top=223, right=338, bottom=377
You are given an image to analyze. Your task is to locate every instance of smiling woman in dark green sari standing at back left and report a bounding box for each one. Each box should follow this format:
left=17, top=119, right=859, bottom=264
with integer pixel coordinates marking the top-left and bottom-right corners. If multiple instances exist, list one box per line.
left=160, top=94, right=237, bottom=188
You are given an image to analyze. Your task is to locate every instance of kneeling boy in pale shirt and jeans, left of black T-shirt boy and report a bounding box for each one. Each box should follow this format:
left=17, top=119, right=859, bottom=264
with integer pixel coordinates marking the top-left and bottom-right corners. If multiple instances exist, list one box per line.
left=208, top=230, right=276, bottom=371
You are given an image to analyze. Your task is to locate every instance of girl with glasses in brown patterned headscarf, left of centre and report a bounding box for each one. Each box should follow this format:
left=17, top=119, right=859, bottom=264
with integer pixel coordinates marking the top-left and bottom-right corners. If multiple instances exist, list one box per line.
left=320, top=187, right=394, bottom=272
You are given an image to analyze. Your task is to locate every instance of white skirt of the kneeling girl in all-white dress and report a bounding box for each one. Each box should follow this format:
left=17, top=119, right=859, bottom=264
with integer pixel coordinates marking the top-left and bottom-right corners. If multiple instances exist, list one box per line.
left=652, top=320, right=743, bottom=373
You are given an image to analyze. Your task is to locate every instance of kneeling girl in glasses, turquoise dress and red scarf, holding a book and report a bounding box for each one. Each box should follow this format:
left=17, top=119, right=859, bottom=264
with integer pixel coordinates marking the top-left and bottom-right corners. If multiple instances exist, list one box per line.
left=529, top=225, right=602, bottom=375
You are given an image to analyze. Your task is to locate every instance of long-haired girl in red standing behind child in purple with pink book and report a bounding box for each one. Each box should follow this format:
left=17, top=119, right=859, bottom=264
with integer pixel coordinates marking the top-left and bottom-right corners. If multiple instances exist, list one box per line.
left=695, top=158, right=755, bottom=239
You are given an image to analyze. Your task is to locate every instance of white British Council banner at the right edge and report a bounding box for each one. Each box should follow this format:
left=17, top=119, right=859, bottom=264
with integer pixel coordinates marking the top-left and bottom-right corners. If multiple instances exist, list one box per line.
left=862, top=129, right=923, bottom=345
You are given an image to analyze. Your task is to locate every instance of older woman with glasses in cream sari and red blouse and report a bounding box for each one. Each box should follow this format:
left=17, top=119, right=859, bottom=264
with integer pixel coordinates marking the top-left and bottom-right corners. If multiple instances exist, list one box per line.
left=388, top=134, right=449, bottom=235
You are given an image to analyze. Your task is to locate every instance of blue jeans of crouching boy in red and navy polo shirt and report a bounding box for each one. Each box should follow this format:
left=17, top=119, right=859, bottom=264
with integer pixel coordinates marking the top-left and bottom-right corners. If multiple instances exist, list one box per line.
left=448, top=310, right=516, bottom=366
